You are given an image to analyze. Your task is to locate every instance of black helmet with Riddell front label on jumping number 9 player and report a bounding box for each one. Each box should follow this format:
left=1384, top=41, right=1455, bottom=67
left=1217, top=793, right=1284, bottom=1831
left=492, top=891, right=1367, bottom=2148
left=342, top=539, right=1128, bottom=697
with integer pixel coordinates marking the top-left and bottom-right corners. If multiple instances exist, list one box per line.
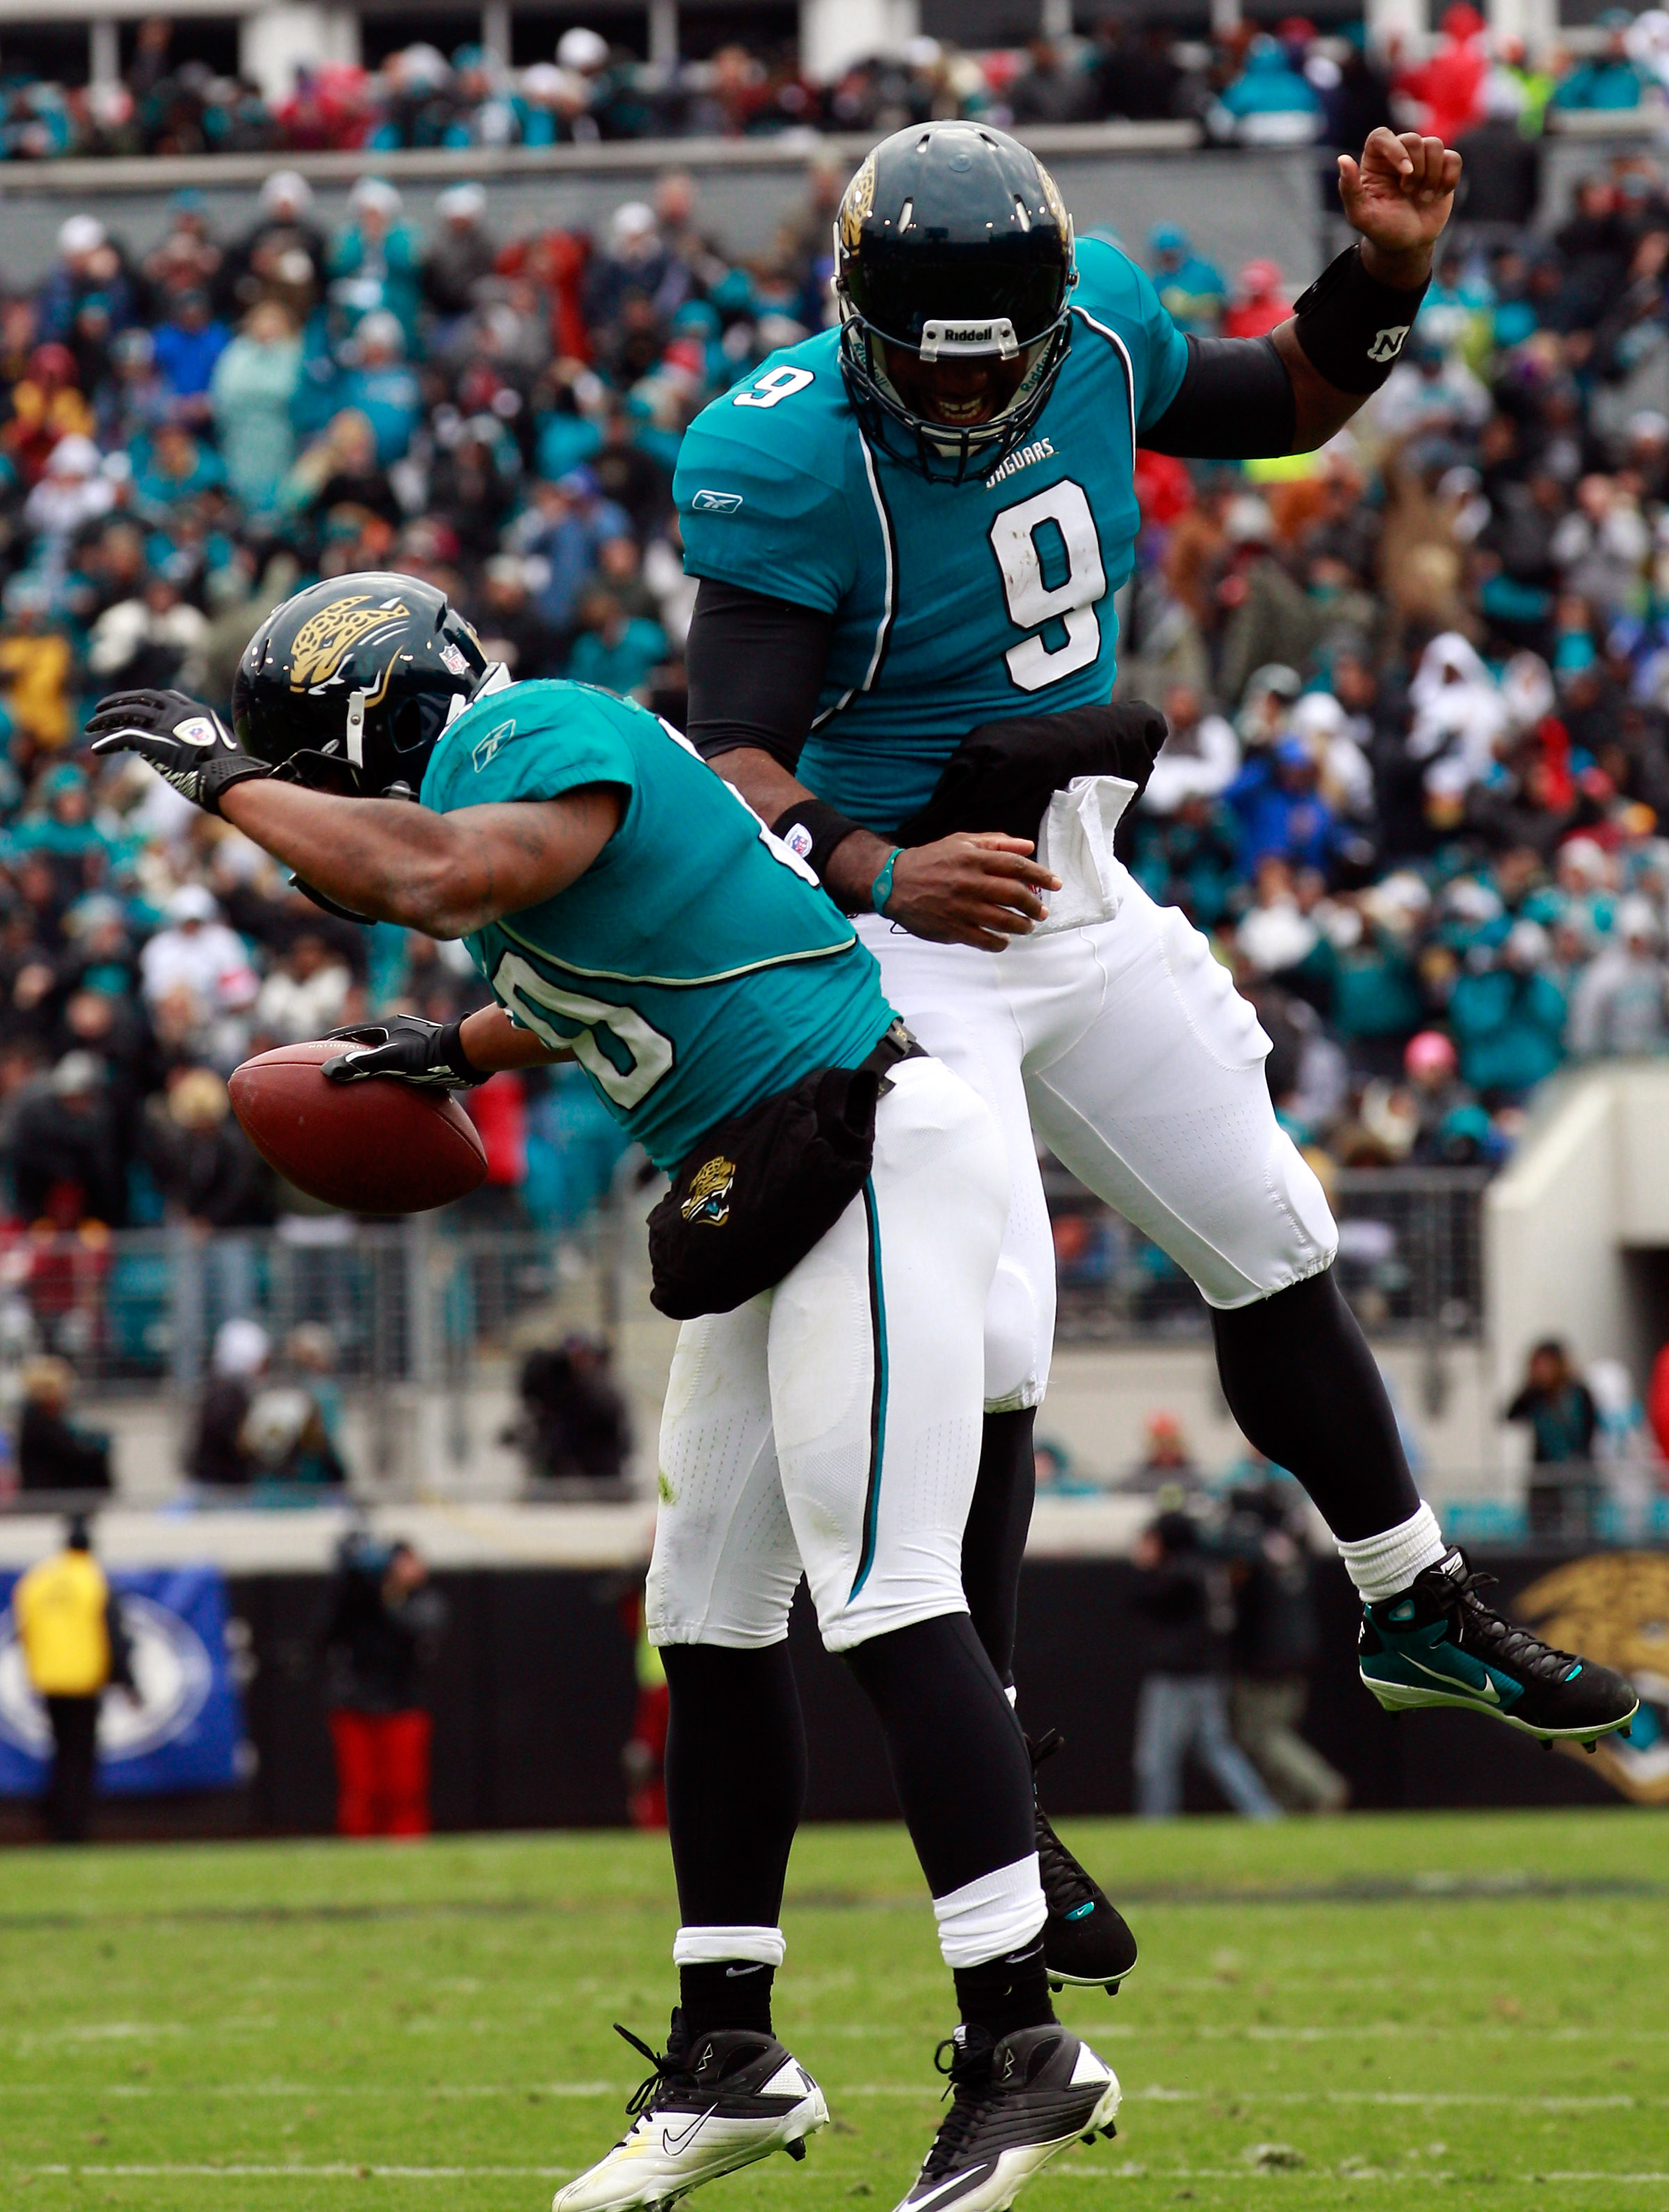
left=836, top=122, right=1077, bottom=484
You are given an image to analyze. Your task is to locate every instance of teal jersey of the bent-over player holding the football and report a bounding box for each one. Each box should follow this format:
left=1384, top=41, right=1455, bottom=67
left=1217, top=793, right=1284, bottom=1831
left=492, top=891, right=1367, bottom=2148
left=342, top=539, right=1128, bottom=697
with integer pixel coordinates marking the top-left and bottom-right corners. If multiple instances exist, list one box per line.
left=420, top=681, right=893, bottom=1170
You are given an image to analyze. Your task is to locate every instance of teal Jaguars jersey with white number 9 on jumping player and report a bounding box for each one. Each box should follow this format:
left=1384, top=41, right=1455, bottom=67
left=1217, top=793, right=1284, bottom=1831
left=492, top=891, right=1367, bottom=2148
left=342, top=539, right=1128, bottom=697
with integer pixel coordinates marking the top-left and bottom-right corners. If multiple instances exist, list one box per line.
left=675, top=239, right=1187, bottom=830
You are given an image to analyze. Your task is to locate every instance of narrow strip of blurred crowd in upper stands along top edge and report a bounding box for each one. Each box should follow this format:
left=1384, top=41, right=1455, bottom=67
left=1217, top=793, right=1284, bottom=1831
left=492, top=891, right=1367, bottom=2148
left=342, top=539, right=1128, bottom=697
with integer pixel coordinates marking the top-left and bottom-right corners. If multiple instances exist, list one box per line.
left=0, top=4, right=1669, bottom=161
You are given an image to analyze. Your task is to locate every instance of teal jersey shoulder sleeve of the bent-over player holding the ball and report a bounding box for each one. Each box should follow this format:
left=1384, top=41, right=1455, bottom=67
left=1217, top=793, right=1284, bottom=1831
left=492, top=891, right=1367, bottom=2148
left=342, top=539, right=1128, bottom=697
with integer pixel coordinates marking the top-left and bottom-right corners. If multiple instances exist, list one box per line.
left=420, top=677, right=654, bottom=814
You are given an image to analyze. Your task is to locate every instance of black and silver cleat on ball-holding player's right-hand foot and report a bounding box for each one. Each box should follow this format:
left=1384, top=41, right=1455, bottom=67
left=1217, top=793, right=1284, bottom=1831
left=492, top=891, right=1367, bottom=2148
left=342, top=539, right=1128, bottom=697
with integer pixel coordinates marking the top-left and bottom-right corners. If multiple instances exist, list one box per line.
left=898, top=2022, right=1118, bottom=2212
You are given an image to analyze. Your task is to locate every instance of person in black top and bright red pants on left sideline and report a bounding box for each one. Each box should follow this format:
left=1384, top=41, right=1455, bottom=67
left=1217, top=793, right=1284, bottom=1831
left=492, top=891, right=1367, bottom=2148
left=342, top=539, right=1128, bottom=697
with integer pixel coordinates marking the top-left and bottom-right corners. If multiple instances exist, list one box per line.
left=319, top=1535, right=446, bottom=1836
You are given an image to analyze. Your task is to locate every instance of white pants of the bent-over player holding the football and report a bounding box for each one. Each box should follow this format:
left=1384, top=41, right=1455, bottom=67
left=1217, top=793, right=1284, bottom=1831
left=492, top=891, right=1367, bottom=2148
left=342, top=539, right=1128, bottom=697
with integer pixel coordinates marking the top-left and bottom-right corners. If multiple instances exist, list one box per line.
left=645, top=1059, right=1008, bottom=1650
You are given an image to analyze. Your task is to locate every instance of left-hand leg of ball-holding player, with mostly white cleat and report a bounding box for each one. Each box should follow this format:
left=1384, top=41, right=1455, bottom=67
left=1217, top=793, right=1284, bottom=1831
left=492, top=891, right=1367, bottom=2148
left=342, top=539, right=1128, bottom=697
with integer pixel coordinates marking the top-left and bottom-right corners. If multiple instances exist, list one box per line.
left=555, top=1296, right=829, bottom=2212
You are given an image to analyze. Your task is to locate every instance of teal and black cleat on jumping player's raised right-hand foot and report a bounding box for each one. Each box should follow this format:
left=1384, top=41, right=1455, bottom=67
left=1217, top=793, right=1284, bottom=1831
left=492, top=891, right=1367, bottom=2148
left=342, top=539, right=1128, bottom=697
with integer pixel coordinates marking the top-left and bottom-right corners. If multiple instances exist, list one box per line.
left=1357, top=1550, right=1640, bottom=1743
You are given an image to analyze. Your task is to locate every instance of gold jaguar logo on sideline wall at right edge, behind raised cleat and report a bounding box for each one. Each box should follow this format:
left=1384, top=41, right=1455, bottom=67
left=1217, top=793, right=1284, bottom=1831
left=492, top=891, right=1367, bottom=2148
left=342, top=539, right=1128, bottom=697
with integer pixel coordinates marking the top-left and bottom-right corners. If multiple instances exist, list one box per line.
left=1512, top=1550, right=1669, bottom=1805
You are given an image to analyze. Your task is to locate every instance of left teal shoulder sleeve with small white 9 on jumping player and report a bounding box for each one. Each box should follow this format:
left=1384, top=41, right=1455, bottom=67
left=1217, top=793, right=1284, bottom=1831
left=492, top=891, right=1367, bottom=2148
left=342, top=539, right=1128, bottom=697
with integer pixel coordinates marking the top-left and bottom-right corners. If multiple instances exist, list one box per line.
left=672, top=330, right=862, bottom=613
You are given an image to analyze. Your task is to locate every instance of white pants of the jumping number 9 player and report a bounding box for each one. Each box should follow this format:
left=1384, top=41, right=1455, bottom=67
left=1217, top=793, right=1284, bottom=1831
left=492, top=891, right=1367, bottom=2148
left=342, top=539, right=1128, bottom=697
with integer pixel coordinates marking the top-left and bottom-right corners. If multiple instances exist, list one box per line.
left=857, top=863, right=1337, bottom=1411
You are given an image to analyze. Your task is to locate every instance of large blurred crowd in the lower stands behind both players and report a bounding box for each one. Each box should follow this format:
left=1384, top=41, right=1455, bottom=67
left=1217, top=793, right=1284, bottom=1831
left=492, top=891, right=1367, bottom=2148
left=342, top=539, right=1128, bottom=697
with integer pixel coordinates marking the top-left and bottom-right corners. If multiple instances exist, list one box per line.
left=0, top=99, right=1669, bottom=1230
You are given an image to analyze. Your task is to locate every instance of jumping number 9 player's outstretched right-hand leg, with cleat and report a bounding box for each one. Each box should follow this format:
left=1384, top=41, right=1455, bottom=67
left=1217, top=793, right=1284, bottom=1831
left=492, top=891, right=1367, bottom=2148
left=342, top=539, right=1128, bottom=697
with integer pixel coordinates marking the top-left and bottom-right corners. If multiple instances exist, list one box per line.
left=1017, top=883, right=1634, bottom=1736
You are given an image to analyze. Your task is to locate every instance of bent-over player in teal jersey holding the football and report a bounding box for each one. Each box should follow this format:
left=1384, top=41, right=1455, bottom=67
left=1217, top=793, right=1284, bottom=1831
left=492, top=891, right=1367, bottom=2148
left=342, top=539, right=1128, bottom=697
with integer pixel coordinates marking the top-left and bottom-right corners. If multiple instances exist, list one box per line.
left=88, top=575, right=1118, bottom=2212
